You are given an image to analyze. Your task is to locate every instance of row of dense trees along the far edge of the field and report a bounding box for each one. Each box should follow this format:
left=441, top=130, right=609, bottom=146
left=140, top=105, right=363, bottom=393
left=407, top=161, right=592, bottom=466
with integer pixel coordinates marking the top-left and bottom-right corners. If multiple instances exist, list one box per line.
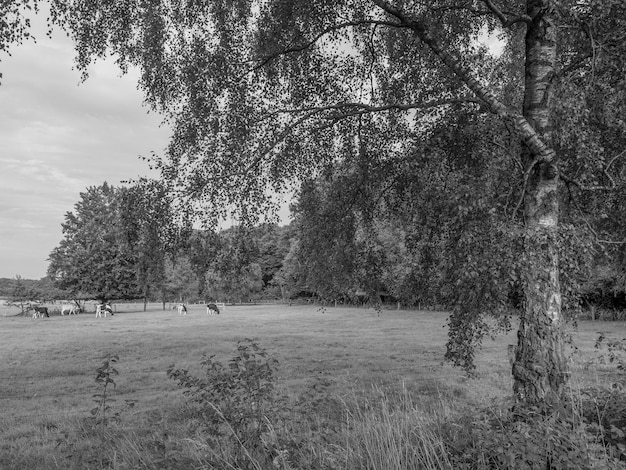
left=0, top=169, right=626, bottom=316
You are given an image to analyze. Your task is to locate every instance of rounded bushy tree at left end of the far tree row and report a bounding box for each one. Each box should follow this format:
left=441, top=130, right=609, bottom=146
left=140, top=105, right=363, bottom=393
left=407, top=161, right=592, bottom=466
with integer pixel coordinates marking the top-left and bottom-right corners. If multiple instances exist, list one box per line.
left=48, top=182, right=142, bottom=300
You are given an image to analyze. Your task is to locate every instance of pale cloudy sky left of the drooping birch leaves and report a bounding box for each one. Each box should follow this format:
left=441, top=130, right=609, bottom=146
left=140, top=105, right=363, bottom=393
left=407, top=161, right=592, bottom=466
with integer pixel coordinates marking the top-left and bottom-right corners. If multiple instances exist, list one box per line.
left=0, top=20, right=169, bottom=279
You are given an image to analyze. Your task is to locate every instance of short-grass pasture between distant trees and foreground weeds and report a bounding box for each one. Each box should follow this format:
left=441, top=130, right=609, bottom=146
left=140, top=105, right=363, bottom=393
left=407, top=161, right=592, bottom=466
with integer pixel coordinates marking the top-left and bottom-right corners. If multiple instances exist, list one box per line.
left=0, top=305, right=626, bottom=469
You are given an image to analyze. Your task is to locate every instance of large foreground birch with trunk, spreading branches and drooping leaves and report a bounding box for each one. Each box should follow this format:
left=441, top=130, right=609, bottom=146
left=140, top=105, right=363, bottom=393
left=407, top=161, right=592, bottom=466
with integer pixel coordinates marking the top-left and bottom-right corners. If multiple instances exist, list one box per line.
left=9, top=0, right=626, bottom=402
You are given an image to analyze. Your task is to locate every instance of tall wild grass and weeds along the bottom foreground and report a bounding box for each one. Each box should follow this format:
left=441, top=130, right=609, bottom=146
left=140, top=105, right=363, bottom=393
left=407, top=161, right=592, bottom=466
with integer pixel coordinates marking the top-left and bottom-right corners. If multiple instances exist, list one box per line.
left=0, top=376, right=626, bottom=470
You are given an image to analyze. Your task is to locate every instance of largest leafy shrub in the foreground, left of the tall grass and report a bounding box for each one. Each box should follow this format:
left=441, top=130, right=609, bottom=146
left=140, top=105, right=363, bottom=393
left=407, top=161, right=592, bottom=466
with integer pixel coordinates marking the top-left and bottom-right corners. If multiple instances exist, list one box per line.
left=167, top=339, right=285, bottom=469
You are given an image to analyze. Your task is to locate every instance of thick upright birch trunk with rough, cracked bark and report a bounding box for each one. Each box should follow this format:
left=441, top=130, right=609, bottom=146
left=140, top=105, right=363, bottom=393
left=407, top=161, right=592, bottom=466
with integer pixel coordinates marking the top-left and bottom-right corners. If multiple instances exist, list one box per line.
left=513, top=0, right=567, bottom=404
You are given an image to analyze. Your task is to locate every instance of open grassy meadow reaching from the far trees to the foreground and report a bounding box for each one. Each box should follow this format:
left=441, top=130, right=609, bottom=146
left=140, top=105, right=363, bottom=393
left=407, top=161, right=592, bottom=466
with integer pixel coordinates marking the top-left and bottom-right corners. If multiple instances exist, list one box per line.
left=0, top=305, right=626, bottom=469
